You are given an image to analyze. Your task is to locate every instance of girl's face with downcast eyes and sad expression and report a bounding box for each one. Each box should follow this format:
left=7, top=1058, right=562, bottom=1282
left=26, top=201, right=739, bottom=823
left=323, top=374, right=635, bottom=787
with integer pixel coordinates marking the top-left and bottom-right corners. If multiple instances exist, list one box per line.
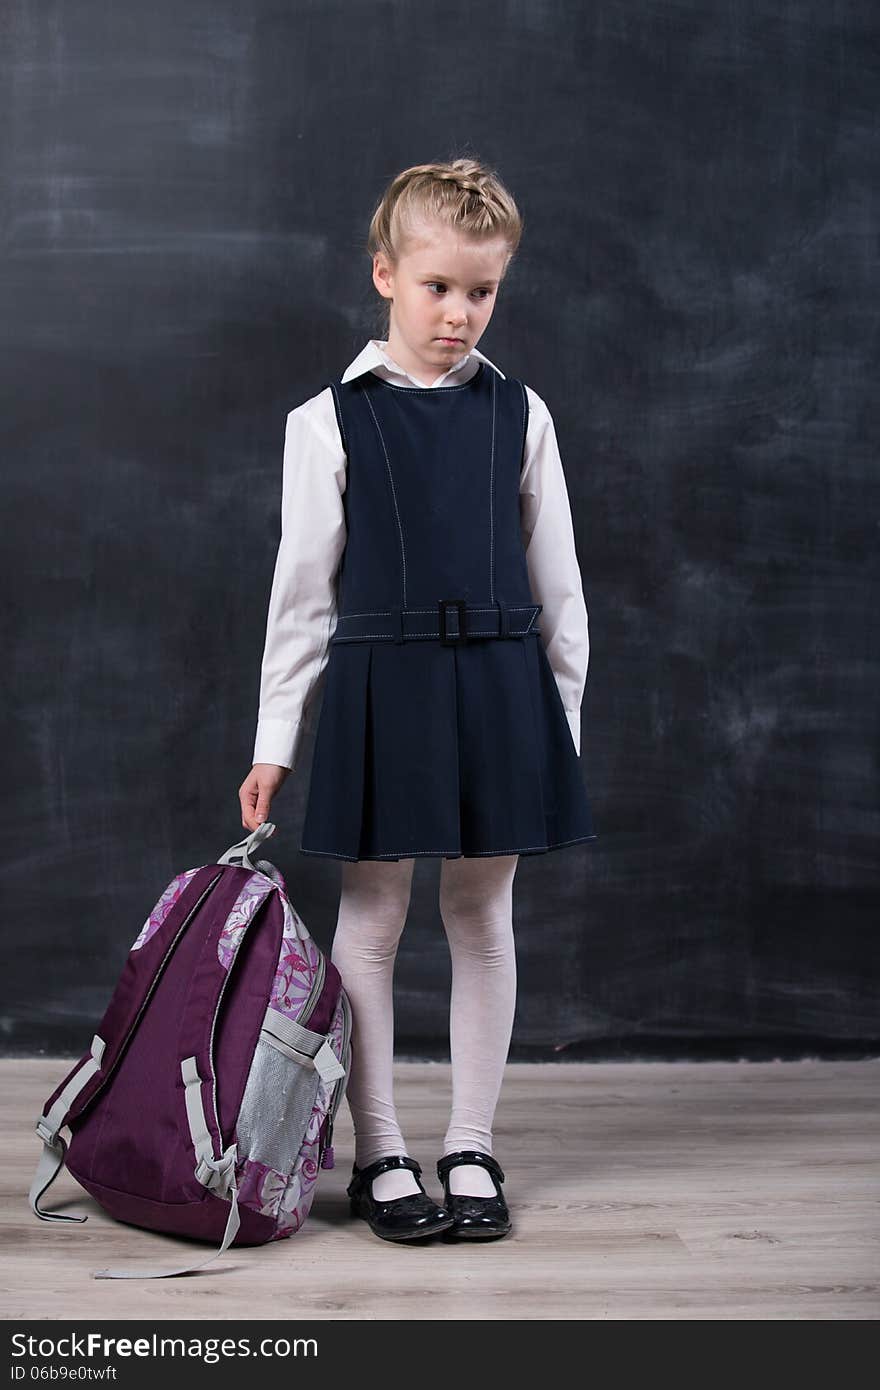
left=373, top=224, right=507, bottom=382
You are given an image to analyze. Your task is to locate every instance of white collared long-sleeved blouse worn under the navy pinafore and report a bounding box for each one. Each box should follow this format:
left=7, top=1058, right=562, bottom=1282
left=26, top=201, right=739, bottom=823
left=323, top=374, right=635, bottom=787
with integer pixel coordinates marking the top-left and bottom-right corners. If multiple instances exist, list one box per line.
left=253, top=338, right=589, bottom=769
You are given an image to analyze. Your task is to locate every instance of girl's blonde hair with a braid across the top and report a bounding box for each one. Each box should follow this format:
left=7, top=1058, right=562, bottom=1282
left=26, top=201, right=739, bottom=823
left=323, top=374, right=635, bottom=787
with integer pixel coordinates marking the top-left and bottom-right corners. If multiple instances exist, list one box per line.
left=367, top=157, right=523, bottom=336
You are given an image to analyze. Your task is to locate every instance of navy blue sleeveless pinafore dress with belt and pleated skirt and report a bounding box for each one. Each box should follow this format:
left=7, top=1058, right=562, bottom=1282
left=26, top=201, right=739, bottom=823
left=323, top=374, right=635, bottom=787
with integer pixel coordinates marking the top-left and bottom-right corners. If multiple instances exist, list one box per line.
left=300, top=361, right=598, bottom=860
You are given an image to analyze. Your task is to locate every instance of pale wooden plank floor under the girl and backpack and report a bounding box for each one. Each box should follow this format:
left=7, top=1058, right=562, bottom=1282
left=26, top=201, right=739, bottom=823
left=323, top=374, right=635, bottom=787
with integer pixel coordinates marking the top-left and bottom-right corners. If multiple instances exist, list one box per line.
left=0, top=1059, right=880, bottom=1321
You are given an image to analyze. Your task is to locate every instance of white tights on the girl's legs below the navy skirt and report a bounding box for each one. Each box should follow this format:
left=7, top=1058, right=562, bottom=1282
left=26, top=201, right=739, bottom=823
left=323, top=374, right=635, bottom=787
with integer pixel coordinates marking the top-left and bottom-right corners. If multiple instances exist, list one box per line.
left=331, top=855, right=519, bottom=1201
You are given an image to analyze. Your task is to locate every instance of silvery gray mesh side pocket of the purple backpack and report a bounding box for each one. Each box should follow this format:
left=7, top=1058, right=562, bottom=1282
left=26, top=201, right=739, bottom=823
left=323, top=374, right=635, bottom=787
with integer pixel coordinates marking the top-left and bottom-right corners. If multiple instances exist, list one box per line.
left=238, top=1038, right=321, bottom=1173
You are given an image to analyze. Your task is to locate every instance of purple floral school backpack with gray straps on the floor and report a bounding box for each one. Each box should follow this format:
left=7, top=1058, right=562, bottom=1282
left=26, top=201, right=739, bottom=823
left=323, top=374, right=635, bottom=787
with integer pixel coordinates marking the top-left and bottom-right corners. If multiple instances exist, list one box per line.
left=29, top=821, right=352, bottom=1279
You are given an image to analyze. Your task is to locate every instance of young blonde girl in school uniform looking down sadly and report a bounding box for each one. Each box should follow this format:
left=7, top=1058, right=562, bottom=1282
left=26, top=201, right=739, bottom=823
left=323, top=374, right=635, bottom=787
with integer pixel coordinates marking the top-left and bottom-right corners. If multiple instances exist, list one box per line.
left=239, top=158, right=598, bottom=1240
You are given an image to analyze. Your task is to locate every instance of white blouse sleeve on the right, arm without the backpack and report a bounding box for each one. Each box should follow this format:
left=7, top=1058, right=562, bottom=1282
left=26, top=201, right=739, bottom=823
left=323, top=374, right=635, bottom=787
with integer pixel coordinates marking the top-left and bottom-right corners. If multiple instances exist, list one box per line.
left=520, top=386, right=589, bottom=756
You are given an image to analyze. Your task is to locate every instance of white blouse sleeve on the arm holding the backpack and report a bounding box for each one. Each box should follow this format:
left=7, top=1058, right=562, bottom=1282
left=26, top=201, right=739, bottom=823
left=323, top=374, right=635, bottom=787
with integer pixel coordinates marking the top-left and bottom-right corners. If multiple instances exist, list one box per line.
left=253, top=400, right=348, bottom=767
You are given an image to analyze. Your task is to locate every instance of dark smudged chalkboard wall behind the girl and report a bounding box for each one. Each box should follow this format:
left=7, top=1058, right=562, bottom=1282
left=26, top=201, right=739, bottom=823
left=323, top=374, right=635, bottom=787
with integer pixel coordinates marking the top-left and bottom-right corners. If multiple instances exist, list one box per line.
left=0, top=0, right=880, bottom=1059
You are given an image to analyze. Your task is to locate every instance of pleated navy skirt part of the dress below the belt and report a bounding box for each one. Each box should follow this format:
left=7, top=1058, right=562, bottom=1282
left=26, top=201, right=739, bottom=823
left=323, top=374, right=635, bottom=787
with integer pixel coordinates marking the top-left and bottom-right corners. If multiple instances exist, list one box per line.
left=299, top=635, right=598, bottom=860
